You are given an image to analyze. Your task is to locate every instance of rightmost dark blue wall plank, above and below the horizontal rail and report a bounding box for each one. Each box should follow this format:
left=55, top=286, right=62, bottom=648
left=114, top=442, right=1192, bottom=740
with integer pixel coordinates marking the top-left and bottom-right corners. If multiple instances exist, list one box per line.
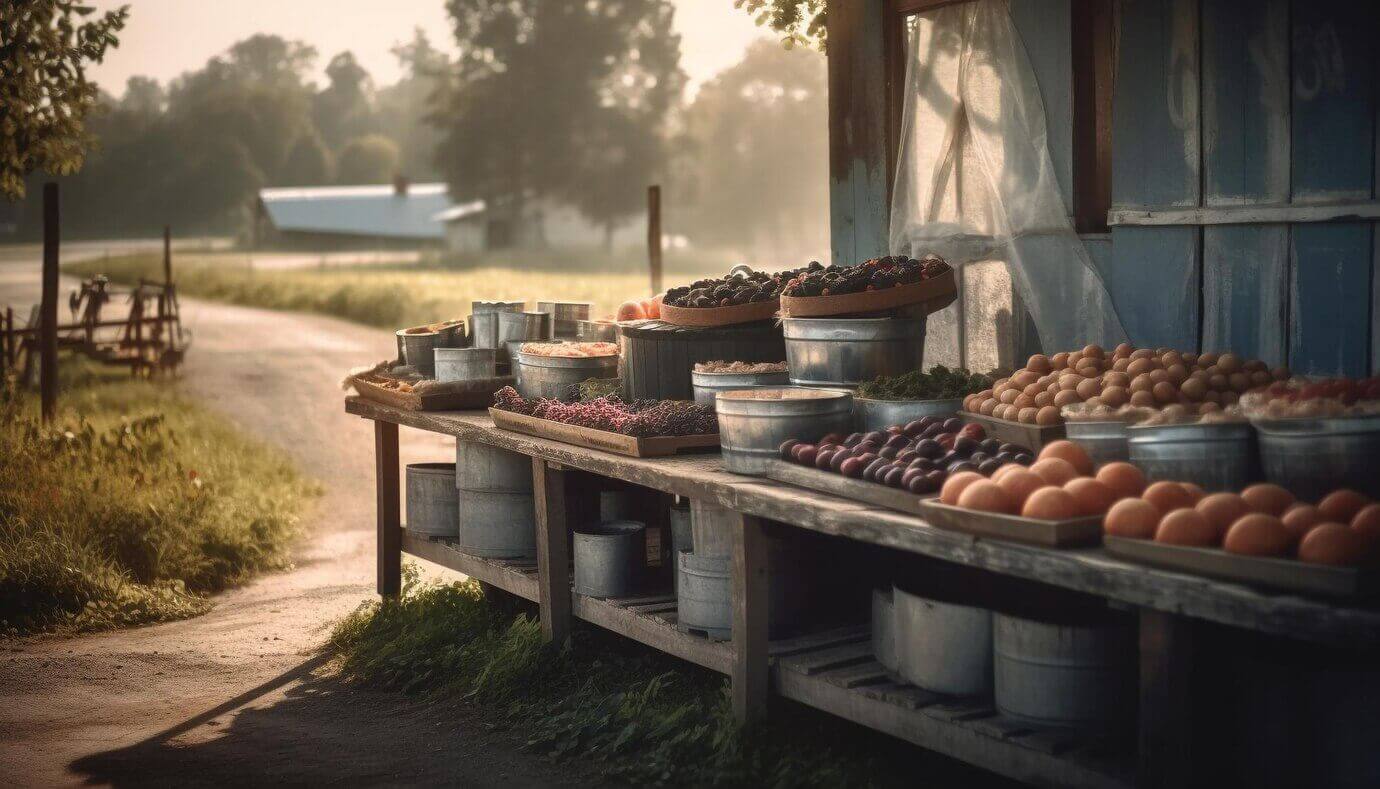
left=1289, top=0, right=1377, bottom=375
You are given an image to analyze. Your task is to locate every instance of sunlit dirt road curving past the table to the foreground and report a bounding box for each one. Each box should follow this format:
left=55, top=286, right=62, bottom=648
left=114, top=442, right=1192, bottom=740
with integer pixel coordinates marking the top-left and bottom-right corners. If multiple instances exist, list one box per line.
left=0, top=259, right=593, bottom=786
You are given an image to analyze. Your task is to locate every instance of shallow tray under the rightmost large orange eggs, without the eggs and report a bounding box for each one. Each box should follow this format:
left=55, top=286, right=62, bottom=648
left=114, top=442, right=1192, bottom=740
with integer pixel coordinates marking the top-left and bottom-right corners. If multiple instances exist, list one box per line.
left=1103, top=535, right=1380, bottom=597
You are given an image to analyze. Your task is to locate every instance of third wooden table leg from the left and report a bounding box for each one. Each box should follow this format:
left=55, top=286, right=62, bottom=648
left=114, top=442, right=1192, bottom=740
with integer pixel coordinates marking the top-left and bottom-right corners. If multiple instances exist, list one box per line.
left=731, top=515, right=769, bottom=723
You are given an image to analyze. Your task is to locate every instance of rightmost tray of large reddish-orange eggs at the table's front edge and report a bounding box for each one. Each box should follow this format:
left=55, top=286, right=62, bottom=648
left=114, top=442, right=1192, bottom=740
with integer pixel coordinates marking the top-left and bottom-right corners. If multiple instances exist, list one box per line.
left=1103, top=481, right=1380, bottom=597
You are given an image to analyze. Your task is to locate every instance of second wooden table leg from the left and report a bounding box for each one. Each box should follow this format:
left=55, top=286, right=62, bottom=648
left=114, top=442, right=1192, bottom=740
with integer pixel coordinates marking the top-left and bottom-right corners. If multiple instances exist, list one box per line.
left=531, top=458, right=570, bottom=644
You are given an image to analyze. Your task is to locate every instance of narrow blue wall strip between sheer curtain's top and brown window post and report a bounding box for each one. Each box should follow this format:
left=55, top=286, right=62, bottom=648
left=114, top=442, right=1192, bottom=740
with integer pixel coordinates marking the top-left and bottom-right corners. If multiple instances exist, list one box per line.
left=1010, top=0, right=1074, bottom=214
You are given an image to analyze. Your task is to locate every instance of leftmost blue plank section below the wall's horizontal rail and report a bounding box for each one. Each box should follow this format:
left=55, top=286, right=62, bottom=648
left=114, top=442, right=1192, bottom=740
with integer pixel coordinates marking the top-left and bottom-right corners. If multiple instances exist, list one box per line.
left=1105, top=228, right=1201, bottom=350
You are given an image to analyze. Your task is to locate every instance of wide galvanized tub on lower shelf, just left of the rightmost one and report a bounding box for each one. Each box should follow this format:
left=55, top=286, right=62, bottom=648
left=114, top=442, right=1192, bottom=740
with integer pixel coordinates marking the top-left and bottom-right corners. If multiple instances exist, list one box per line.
left=891, top=586, right=992, bottom=695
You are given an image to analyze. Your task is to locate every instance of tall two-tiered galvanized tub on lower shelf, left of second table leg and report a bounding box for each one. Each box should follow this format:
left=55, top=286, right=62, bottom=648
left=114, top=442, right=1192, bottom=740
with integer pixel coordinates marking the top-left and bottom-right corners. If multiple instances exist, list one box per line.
left=453, top=441, right=537, bottom=559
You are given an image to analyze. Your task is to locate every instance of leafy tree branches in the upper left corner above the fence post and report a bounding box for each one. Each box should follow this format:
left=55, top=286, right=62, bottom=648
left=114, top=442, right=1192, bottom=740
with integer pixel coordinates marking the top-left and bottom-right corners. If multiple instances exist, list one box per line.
left=0, top=0, right=130, bottom=200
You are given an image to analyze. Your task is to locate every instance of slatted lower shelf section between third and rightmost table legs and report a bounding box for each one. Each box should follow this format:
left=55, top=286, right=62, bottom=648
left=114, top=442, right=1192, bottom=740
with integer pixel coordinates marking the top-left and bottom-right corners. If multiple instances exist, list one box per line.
left=771, top=628, right=1134, bottom=789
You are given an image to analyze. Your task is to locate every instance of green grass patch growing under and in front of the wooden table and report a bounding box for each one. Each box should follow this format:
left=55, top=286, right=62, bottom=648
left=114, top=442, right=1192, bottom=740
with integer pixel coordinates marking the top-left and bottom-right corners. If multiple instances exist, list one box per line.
left=326, top=566, right=1004, bottom=788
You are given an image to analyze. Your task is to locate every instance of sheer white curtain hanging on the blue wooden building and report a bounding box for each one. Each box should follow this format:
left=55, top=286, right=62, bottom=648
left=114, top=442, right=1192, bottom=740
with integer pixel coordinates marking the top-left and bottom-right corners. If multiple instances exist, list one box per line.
left=890, top=0, right=1126, bottom=366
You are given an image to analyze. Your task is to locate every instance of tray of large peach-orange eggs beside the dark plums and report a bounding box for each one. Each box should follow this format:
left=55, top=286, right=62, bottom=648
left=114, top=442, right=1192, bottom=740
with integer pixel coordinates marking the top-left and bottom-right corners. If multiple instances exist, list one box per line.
left=919, top=440, right=1145, bottom=548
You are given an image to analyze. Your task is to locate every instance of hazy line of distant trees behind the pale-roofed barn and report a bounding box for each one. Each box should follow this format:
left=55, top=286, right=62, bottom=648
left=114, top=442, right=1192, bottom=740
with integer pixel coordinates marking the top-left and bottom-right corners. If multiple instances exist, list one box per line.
left=10, top=0, right=828, bottom=257
